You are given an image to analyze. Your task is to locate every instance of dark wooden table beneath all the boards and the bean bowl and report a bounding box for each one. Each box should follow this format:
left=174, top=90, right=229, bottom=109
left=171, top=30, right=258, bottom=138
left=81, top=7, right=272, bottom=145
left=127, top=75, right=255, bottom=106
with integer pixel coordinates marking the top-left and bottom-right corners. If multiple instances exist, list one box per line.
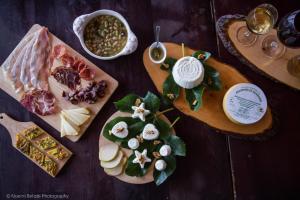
left=0, top=0, right=300, bottom=200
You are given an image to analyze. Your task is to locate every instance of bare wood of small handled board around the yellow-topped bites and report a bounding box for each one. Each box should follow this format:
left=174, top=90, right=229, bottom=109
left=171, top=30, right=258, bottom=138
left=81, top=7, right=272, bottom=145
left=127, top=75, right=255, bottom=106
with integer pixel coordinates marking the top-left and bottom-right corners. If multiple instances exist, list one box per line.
left=0, top=113, right=73, bottom=177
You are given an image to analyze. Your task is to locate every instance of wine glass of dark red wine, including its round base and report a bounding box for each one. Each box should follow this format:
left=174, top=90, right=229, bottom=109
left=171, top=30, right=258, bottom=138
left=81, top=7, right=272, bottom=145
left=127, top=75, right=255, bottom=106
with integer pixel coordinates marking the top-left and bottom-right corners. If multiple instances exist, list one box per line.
left=262, top=10, right=300, bottom=58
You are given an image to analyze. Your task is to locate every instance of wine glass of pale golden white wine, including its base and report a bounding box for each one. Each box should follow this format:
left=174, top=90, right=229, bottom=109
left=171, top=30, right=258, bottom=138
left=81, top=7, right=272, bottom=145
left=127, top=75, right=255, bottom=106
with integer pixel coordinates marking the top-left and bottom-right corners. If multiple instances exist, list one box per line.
left=237, top=4, right=278, bottom=46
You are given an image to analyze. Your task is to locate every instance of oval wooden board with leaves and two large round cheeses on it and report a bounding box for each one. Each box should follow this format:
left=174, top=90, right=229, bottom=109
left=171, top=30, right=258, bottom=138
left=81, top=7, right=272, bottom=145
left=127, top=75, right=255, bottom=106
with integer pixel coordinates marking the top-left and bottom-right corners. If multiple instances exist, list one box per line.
left=143, top=43, right=273, bottom=136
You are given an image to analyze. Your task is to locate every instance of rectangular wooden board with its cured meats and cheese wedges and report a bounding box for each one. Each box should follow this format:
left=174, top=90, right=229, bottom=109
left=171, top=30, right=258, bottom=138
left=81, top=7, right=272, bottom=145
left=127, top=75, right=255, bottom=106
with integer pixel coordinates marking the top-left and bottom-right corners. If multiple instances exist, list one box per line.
left=0, top=24, right=118, bottom=142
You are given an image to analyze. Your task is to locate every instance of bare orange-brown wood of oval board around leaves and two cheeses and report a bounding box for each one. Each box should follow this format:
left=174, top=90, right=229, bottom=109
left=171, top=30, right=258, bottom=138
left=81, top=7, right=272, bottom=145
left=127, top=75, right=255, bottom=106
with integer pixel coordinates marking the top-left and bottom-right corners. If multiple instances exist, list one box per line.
left=143, top=43, right=273, bottom=135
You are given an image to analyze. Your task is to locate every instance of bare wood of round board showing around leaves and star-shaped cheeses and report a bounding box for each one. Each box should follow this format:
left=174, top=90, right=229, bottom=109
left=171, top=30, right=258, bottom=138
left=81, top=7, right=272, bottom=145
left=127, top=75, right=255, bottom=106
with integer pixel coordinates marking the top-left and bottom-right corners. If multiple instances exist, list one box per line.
left=99, top=111, right=175, bottom=184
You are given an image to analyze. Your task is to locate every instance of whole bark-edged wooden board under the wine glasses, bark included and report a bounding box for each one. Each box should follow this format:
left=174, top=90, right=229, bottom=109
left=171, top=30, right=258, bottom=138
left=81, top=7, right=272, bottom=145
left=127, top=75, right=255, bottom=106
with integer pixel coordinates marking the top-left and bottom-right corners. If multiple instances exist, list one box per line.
left=217, top=15, right=300, bottom=90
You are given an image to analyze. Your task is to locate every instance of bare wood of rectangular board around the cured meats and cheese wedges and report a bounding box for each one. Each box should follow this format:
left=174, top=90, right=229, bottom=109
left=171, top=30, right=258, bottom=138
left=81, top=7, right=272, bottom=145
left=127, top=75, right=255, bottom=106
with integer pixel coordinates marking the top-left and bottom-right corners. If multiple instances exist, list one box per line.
left=0, top=24, right=118, bottom=142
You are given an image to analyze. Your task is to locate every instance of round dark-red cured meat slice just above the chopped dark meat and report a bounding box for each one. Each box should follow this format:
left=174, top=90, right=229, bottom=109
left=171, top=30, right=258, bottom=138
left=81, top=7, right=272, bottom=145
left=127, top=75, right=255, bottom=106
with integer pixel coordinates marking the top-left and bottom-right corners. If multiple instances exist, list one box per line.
left=51, top=66, right=80, bottom=90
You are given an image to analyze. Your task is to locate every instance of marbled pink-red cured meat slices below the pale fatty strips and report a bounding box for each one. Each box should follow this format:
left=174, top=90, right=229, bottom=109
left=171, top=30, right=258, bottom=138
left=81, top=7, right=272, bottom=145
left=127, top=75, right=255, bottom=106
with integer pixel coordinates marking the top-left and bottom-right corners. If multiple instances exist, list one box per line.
left=20, top=90, right=56, bottom=116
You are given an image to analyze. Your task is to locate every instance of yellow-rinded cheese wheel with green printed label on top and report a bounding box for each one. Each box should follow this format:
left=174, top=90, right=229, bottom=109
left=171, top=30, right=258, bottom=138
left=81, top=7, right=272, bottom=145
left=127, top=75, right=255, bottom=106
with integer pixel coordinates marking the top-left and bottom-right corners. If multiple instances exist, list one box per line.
left=223, top=83, right=267, bottom=124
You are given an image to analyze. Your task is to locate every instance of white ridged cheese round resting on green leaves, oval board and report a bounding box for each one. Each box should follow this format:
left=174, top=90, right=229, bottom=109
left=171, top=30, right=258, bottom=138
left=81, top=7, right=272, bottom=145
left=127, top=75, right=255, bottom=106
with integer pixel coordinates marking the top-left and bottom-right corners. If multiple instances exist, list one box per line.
left=172, top=56, right=204, bottom=89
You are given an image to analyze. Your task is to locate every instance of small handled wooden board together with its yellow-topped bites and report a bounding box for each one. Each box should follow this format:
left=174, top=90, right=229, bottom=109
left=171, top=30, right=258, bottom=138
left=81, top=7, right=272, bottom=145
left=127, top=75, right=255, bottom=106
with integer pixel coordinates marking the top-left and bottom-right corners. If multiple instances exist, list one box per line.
left=0, top=113, right=72, bottom=177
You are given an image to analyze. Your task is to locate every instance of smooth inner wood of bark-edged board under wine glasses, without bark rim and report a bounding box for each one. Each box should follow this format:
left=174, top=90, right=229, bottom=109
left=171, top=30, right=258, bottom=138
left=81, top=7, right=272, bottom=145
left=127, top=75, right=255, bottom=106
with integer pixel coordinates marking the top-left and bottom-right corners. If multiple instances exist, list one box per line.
left=226, top=20, right=300, bottom=90
